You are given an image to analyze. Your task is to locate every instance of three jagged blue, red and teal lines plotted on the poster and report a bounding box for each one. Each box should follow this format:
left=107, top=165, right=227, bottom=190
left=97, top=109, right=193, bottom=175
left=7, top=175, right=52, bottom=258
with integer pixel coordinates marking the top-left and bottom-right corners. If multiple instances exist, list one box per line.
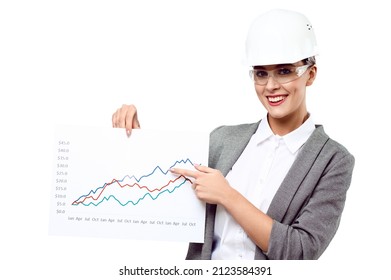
left=72, top=159, right=193, bottom=206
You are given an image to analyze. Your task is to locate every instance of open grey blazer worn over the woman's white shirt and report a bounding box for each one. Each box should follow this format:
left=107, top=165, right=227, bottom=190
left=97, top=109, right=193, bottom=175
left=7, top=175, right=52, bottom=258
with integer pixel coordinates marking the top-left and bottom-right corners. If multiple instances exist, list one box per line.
left=186, top=122, right=354, bottom=260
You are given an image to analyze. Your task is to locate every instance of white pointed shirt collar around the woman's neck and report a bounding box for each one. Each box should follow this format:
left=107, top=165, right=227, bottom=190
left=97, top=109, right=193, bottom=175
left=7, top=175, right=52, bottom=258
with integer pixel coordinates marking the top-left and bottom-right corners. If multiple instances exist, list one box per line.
left=255, top=115, right=315, bottom=153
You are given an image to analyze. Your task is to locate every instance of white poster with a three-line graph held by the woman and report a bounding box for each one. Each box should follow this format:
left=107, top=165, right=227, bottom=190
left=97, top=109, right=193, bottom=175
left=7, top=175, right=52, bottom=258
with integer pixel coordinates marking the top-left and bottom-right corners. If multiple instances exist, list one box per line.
left=49, top=126, right=209, bottom=242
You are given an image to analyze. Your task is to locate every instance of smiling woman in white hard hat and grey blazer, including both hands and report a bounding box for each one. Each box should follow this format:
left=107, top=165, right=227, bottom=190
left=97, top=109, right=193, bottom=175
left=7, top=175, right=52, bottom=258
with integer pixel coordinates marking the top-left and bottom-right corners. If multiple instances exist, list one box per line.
left=112, top=10, right=354, bottom=259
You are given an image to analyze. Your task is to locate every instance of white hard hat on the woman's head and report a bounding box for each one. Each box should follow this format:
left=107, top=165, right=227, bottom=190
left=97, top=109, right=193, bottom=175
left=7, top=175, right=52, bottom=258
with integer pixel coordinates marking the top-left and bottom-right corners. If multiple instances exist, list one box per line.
left=246, top=9, right=318, bottom=66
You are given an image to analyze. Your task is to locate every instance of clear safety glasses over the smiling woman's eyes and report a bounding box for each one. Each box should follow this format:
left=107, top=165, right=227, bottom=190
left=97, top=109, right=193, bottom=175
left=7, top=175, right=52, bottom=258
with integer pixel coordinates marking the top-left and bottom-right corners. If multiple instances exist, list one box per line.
left=250, top=65, right=312, bottom=86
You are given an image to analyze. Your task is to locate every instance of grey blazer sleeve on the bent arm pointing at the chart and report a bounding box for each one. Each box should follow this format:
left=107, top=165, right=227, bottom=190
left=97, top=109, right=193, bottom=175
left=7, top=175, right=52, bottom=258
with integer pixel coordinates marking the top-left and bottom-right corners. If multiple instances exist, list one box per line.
left=266, top=139, right=354, bottom=260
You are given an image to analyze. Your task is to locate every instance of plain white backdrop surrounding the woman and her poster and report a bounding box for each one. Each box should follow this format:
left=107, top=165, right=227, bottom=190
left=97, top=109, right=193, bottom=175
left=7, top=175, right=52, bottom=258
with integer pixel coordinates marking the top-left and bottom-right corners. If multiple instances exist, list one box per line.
left=0, top=0, right=391, bottom=279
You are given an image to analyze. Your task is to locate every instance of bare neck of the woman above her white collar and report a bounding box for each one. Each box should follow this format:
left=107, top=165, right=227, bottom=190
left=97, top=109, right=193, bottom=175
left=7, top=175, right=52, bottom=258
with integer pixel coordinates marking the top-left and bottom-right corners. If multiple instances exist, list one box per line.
left=267, top=112, right=310, bottom=136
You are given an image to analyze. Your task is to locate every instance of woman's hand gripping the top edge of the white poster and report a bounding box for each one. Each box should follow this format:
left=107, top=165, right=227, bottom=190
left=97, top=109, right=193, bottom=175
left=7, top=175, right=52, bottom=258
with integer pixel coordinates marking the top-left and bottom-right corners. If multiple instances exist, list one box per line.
left=112, top=104, right=140, bottom=136
